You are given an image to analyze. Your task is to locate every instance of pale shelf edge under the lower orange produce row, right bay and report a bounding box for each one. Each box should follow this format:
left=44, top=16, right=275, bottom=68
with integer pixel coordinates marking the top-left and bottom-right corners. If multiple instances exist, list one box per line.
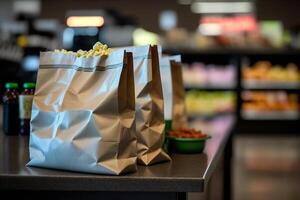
left=241, top=111, right=299, bottom=120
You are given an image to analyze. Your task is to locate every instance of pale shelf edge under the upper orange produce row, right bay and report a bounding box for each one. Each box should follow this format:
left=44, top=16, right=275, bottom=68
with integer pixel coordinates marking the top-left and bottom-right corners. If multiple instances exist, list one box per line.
left=242, top=80, right=300, bottom=90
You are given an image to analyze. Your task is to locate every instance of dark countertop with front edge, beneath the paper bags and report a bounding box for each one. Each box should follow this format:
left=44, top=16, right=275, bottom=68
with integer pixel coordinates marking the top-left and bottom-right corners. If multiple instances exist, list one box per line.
left=0, top=120, right=233, bottom=192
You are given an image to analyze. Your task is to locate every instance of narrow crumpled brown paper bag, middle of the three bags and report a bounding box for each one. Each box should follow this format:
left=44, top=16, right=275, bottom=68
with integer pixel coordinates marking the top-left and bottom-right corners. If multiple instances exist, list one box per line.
left=119, top=45, right=171, bottom=165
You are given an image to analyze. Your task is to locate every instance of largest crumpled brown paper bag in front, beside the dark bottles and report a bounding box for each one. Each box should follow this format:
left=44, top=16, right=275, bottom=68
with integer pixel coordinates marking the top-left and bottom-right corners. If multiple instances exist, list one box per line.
left=28, top=47, right=137, bottom=175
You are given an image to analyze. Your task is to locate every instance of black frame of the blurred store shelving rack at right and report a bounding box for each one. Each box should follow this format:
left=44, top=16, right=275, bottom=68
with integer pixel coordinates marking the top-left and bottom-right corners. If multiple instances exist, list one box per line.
left=164, top=48, right=300, bottom=133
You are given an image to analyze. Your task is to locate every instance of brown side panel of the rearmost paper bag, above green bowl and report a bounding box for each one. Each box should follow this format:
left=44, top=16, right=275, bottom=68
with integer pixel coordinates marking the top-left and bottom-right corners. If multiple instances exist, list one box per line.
left=169, top=55, right=188, bottom=129
